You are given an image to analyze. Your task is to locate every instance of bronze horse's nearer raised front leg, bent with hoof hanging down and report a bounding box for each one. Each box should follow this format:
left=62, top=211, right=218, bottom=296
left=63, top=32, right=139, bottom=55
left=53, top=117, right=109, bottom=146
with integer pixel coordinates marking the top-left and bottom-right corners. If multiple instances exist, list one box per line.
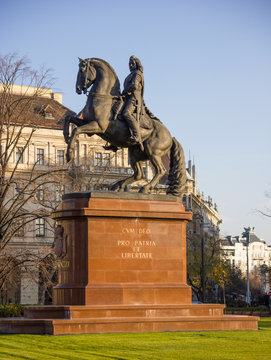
left=66, top=118, right=103, bottom=162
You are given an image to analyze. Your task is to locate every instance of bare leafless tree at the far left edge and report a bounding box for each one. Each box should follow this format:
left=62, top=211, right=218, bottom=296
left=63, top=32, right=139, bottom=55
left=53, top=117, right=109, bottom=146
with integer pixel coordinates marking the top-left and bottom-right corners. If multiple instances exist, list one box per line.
left=0, top=54, right=63, bottom=296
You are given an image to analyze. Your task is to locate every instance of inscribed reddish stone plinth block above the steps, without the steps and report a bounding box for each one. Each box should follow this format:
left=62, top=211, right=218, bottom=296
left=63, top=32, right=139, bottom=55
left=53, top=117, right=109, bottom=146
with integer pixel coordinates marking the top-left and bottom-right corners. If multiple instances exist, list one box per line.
left=54, top=192, right=192, bottom=305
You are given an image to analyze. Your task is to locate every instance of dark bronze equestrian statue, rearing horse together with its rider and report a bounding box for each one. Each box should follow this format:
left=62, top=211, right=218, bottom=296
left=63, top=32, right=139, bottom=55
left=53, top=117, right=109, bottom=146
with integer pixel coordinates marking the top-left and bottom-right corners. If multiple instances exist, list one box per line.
left=64, top=56, right=186, bottom=196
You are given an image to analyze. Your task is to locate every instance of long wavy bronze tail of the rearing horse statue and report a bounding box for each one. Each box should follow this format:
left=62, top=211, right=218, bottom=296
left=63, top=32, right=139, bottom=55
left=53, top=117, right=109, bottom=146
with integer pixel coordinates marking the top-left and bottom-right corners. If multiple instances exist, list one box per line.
left=167, top=138, right=186, bottom=196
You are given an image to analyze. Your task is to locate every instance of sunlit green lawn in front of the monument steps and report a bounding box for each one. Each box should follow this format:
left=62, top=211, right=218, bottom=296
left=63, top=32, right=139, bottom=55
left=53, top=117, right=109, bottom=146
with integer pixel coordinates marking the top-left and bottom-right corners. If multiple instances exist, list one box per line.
left=0, top=318, right=271, bottom=360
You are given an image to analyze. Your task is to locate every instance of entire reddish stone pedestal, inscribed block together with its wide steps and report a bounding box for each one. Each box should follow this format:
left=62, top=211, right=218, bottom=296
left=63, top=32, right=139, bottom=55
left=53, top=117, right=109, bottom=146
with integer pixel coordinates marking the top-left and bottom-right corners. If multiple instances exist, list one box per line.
left=0, top=192, right=258, bottom=335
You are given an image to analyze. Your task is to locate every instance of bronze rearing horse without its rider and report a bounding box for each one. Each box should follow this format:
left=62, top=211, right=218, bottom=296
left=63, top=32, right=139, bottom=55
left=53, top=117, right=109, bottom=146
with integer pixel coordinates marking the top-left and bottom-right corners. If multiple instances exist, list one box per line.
left=64, top=58, right=186, bottom=196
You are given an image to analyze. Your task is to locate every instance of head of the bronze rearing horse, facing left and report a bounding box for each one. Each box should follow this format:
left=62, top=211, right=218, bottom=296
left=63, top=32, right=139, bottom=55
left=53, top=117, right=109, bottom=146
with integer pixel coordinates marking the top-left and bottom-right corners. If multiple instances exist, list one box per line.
left=76, top=58, right=96, bottom=94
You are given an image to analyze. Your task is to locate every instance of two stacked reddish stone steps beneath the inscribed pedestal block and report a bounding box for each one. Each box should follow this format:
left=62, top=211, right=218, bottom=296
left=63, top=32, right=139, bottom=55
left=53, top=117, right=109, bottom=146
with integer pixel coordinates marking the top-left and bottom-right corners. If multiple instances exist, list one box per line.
left=0, top=304, right=259, bottom=335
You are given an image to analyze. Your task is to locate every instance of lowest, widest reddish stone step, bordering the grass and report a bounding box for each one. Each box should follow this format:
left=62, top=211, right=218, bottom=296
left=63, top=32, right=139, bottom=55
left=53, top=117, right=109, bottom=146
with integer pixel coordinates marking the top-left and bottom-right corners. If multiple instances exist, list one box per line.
left=0, top=315, right=259, bottom=335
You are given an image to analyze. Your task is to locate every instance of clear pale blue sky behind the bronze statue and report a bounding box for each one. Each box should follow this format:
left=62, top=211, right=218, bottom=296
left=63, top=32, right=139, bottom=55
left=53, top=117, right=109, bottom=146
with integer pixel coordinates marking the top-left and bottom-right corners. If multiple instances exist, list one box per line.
left=0, top=0, right=271, bottom=244
